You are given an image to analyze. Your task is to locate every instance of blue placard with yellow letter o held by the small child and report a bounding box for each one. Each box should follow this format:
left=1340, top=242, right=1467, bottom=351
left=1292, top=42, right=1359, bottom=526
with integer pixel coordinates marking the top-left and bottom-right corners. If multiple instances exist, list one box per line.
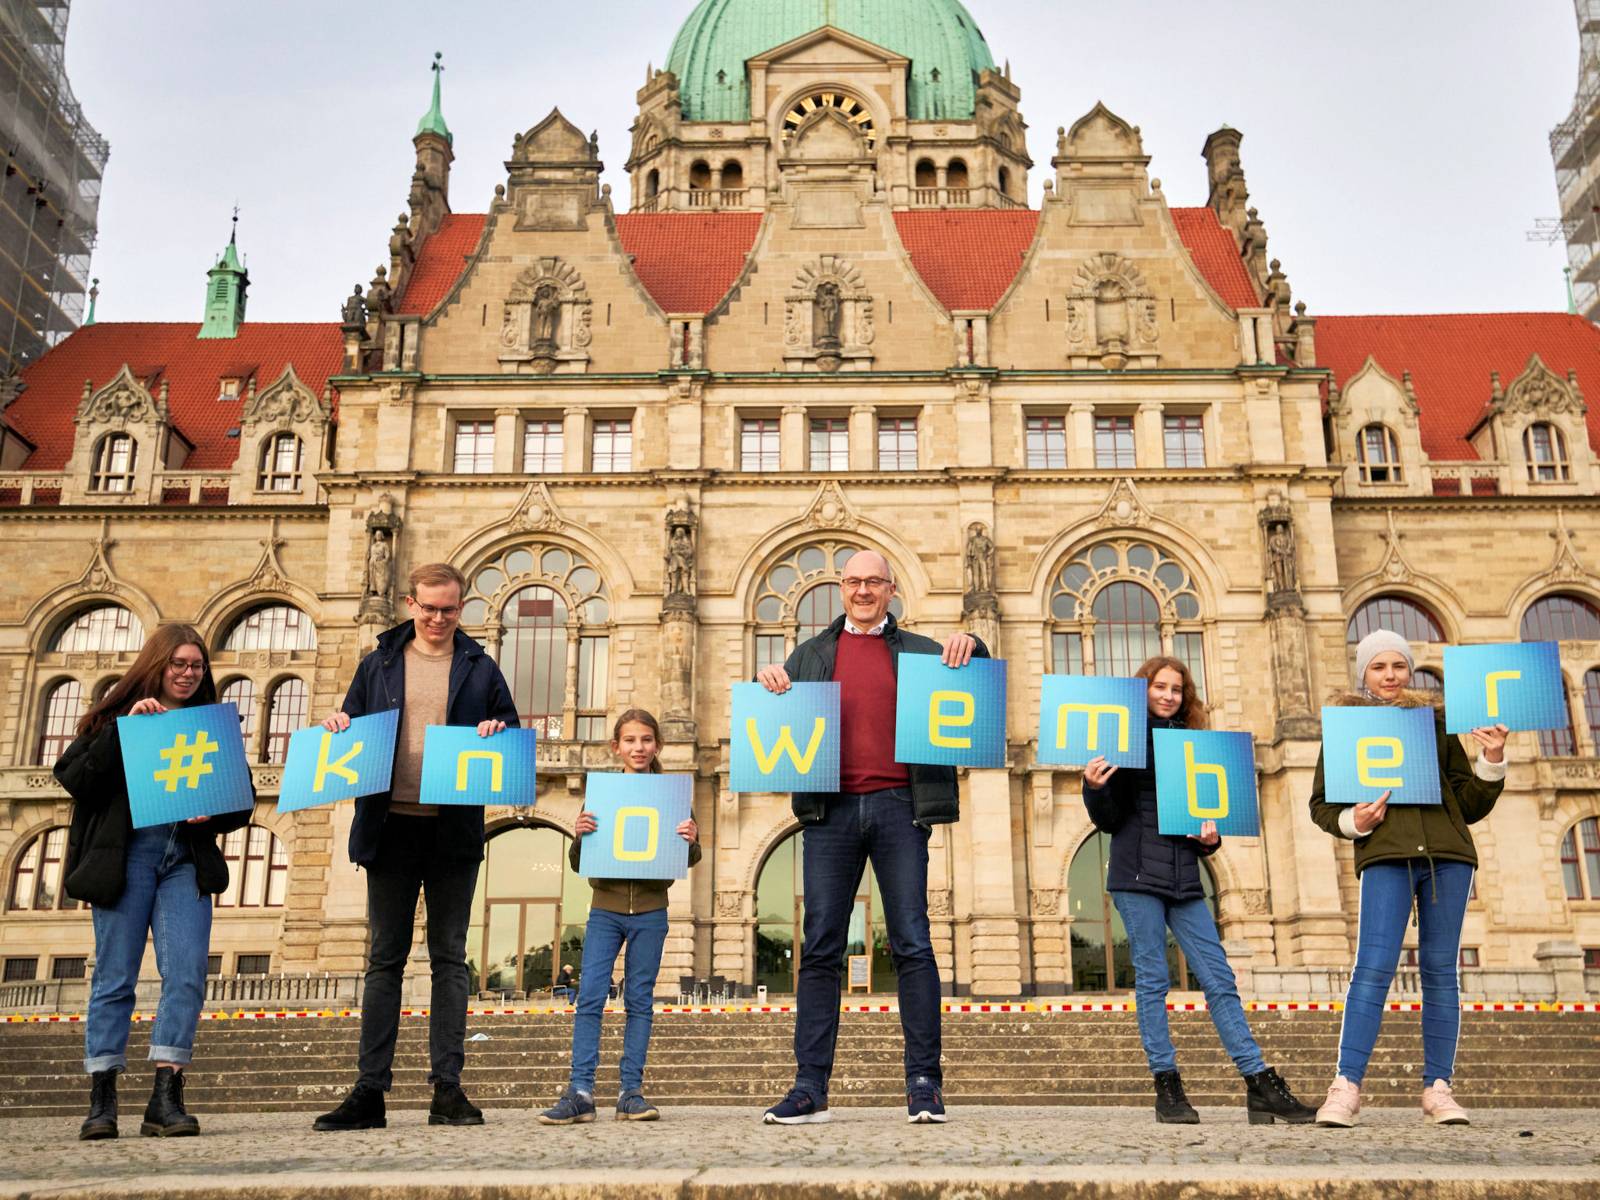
left=578, top=773, right=693, bottom=878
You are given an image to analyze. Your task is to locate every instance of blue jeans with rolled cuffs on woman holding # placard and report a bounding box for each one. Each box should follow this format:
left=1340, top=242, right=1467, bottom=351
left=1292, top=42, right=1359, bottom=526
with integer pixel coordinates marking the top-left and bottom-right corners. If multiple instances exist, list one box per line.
left=83, top=826, right=211, bottom=1074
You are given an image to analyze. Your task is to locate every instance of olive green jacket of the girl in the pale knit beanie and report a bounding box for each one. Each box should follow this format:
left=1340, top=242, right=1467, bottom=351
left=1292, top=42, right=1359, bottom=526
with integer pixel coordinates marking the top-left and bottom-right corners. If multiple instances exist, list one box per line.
left=1310, top=691, right=1506, bottom=875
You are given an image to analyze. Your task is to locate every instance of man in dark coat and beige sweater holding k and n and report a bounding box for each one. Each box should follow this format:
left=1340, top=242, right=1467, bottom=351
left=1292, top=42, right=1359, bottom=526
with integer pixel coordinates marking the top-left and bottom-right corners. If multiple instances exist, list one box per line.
left=312, top=563, right=515, bottom=1131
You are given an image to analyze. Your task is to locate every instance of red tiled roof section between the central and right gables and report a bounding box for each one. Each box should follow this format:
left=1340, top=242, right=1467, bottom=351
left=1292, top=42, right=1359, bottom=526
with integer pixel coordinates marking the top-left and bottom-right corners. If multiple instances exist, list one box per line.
left=894, top=208, right=1038, bottom=312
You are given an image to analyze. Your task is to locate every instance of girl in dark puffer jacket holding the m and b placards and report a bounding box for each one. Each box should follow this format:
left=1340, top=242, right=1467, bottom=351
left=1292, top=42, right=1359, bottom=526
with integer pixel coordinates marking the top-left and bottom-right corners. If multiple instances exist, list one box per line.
left=1083, top=656, right=1315, bottom=1125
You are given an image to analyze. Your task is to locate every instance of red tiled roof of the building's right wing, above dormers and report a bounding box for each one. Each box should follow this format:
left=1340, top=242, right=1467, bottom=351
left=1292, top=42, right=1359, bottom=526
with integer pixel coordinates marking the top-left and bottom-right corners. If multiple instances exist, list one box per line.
left=1317, top=312, right=1600, bottom=461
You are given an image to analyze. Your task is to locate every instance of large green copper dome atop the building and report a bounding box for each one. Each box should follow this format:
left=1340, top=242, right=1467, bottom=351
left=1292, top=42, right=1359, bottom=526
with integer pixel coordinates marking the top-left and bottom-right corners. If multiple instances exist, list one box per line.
left=667, top=0, right=995, bottom=122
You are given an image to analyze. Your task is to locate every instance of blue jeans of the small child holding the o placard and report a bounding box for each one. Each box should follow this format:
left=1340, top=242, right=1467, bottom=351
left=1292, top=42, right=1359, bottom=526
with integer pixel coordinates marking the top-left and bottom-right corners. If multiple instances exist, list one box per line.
left=573, top=909, right=667, bottom=1096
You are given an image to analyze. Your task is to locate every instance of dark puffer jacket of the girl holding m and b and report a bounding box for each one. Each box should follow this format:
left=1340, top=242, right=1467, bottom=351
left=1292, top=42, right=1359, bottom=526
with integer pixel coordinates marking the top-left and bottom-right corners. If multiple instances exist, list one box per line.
left=1083, top=717, right=1222, bottom=901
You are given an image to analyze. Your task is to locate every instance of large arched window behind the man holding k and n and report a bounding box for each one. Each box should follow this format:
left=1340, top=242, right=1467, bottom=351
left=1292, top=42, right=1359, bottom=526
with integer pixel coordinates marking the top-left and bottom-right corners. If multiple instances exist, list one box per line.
left=461, top=546, right=611, bottom=741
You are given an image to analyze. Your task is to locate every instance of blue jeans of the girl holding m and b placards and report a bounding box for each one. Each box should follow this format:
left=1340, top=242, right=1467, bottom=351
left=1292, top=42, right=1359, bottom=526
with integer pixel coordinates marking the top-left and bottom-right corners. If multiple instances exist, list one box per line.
left=1110, top=891, right=1267, bottom=1075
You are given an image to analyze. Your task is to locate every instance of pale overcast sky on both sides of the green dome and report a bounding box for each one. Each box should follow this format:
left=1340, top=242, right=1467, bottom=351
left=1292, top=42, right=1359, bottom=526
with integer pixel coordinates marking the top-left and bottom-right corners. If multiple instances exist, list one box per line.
left=67, top=0, right=1578, bottom=320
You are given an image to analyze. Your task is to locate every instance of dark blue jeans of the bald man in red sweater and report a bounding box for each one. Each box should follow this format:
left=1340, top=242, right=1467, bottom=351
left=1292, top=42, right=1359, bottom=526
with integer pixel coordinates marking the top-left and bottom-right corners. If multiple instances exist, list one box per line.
left=795, top=787, right=944, bottom=1099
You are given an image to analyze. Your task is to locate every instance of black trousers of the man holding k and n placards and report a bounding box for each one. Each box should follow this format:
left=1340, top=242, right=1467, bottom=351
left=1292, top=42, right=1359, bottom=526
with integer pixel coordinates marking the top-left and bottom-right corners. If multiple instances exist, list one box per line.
left=350, top=813, right=480, bottom=1091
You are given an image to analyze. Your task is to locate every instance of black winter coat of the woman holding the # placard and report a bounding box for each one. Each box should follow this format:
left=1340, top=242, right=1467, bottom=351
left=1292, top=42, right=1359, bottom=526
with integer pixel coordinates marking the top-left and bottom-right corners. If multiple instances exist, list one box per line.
left=54, top=720, right=251, bottom=907
